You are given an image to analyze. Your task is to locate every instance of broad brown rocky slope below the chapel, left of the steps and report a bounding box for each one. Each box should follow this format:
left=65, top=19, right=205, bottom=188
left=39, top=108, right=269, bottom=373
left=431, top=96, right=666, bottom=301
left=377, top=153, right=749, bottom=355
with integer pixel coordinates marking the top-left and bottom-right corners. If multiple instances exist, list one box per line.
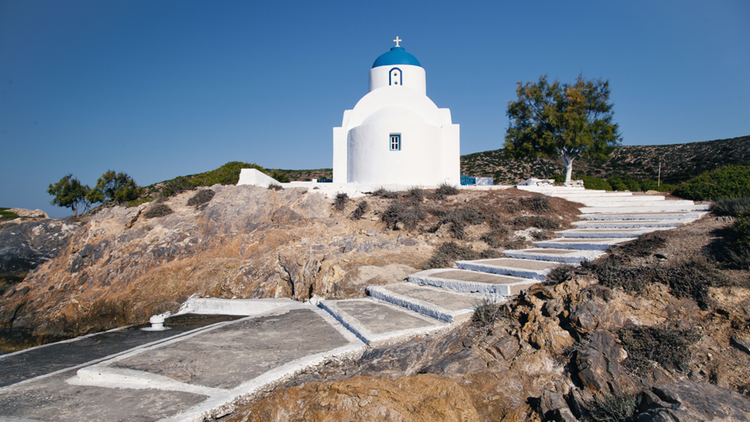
left=0, top=185, right=432, bottom=344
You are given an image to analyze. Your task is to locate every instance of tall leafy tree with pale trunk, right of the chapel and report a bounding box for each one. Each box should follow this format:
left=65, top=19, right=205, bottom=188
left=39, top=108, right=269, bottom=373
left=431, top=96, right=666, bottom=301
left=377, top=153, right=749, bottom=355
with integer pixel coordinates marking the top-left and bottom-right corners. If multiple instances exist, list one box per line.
left=505, top=75, right=621, bottom=183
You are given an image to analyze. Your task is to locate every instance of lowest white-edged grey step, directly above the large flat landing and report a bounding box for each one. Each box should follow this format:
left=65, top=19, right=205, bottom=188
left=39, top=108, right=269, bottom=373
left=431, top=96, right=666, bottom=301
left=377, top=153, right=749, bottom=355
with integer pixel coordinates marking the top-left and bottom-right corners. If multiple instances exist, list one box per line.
left=317, top=299, right=450, bottom=346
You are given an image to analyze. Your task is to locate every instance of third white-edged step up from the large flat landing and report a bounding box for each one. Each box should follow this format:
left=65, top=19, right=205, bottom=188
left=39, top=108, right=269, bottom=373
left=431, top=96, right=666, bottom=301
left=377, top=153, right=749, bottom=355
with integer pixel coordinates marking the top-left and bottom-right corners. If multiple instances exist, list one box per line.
left=407, top=268, right=539, bottom=300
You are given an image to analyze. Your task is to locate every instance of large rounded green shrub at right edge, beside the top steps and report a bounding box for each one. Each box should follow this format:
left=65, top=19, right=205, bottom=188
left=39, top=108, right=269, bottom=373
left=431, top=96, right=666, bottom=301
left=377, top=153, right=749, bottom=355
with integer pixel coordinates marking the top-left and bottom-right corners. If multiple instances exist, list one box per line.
left=674, top=166, right=750, bottom=201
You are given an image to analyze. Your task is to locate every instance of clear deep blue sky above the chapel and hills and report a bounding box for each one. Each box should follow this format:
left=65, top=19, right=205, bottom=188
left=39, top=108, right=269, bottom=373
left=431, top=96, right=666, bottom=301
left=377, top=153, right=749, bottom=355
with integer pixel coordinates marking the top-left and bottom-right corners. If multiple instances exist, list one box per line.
left=0, top=0, right=750, bottom=217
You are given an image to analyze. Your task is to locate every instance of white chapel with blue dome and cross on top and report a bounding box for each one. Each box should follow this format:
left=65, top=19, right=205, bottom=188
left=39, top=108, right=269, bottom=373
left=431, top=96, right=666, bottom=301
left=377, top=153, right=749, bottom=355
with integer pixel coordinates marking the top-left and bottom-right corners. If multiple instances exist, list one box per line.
left=333, top=37, right=460, bottom=187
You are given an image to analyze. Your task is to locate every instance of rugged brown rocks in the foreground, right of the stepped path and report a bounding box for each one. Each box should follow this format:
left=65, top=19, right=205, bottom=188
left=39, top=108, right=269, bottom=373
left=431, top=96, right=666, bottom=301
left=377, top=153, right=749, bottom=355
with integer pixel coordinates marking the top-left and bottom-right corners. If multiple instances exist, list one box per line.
left=229, top=216, right=750, bottom=422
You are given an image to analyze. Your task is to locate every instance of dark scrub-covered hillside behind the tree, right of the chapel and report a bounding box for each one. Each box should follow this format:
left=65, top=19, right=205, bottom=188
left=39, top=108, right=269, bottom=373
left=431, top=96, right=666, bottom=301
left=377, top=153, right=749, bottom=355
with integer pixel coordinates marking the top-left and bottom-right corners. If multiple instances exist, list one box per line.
left=461, top=136, right=750, bottom=184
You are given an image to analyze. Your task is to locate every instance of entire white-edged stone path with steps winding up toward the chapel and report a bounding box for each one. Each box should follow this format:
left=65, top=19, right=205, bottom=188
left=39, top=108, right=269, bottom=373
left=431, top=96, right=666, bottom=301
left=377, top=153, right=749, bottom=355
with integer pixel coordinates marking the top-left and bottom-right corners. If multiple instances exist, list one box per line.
left=0, top=187, right=706, bottom=422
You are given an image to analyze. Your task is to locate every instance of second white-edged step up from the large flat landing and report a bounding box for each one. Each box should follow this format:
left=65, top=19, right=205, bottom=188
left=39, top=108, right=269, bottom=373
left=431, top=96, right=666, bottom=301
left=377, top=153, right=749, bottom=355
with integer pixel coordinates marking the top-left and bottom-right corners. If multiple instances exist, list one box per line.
left=367, top=283, right=482, bottom=323
